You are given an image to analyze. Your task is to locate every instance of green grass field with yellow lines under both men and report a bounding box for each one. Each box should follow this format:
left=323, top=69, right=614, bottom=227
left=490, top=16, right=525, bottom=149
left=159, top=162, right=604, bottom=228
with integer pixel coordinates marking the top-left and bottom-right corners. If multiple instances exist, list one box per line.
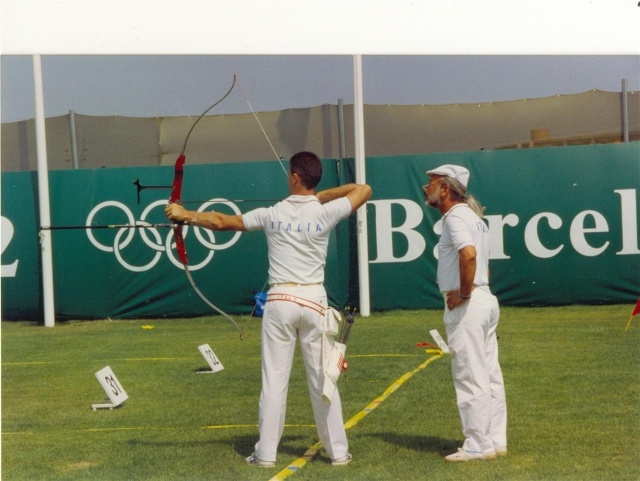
left=2, top=305, right=640, bottom=481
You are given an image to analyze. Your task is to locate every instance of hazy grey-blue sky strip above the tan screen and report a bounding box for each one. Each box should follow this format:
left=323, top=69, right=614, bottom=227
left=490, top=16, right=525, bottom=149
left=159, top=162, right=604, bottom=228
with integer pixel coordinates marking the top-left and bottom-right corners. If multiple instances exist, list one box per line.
left=0, top=55, right=640, bottom=122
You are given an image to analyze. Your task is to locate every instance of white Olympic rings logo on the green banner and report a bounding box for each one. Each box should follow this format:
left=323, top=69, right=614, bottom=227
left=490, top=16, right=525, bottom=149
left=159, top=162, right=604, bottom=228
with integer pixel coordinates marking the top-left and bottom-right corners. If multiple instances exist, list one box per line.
left=86, top=199, right=242, bottom=272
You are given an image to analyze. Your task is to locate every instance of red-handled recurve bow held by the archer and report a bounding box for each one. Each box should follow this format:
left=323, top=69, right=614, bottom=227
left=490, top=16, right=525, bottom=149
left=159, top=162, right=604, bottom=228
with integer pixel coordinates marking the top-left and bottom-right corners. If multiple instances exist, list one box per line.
left=169, top=75, right=243, bottom=340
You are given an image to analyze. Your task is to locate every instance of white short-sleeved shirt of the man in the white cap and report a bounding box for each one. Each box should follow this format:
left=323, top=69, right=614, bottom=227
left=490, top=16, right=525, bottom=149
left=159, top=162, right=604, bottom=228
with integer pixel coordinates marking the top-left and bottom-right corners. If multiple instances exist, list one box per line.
left=438, top=204, right=489, bottom=292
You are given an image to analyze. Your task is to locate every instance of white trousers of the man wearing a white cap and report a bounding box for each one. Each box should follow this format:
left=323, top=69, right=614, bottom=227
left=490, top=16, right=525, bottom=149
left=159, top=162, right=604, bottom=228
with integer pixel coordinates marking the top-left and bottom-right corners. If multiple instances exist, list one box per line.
left=444, top=287, right=507, bottom=453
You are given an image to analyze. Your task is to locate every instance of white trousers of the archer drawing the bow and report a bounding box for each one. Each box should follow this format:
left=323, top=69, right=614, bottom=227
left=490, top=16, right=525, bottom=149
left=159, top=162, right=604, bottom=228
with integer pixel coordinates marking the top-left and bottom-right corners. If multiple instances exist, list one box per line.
left=256, top=286, right=349, bottom=461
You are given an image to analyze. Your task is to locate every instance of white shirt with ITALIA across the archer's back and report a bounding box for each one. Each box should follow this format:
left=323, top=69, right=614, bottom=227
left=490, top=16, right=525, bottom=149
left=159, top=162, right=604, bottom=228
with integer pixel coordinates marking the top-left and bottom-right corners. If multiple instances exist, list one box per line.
left=242, top=195, right=351, bottom=285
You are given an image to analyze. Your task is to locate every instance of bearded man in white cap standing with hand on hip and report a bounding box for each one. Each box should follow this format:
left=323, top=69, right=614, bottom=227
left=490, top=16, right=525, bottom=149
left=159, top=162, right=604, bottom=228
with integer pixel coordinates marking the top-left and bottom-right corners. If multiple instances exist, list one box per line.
left=423, top=164, right=507, bottom=462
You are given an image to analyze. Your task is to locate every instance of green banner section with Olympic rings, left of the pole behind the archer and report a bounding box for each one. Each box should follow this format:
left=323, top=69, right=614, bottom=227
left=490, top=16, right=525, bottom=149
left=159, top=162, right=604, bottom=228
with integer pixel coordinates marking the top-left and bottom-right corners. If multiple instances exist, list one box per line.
left=2, top=161, right=348, bottom=319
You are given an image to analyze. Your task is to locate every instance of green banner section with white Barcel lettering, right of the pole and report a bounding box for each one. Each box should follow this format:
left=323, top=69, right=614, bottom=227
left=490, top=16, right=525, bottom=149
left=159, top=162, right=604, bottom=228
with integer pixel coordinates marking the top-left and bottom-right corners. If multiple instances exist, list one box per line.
left=367, top=142, right=640, bottom=309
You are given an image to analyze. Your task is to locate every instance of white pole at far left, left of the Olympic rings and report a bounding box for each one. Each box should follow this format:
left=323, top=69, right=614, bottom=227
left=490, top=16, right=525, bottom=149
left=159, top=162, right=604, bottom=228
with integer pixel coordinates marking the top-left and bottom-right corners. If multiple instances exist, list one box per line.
left=33, top=55, right=56, bottom=327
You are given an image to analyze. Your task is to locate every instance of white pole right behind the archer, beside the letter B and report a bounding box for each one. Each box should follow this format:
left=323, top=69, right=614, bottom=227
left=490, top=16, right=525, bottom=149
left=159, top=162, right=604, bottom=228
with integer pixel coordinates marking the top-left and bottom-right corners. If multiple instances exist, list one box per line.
left=353, top=55, right=371, bottom=317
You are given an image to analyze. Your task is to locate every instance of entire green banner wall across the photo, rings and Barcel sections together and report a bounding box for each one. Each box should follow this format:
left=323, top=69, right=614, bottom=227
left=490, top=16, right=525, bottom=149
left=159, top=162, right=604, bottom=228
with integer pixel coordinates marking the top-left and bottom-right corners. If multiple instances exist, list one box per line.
left=2, top=143, right=640, bottom=319
